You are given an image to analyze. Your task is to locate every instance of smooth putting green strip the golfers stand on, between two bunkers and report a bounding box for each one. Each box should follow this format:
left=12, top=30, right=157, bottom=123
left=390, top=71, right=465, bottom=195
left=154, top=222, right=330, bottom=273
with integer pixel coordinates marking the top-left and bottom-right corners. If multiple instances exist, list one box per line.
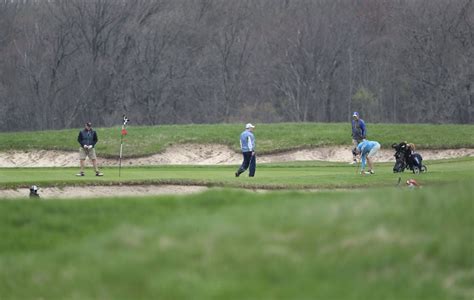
left=0, top=157, right=474, bottom=189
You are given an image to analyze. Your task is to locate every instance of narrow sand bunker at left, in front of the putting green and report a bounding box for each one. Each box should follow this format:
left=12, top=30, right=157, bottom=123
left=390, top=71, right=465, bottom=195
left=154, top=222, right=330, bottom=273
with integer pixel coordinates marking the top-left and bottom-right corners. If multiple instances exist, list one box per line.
left=0, top=185, right=208, bottom=199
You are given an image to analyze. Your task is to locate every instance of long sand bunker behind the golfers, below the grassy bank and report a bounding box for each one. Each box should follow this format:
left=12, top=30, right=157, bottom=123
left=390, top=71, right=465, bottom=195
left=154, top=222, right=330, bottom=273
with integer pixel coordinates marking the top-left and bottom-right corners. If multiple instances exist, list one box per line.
left=0, top=144, right=474, bottom=168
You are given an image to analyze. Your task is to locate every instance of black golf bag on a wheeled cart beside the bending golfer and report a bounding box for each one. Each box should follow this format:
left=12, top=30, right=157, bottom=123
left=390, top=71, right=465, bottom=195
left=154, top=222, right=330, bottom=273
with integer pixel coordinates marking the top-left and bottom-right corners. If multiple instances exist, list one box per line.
left=392, top=142, right=428, bottom=174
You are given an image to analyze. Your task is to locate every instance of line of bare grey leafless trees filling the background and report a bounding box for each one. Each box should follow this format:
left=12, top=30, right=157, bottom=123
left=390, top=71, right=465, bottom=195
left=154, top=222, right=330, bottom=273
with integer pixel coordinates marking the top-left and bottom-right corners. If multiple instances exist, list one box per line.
left=0, top=0, right=474, bottom=131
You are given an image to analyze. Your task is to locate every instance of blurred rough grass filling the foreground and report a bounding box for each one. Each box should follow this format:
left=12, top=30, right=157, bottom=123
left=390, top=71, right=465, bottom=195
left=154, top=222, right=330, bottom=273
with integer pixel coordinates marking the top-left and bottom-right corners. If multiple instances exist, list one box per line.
left=0, top=184, right=474, bottom=300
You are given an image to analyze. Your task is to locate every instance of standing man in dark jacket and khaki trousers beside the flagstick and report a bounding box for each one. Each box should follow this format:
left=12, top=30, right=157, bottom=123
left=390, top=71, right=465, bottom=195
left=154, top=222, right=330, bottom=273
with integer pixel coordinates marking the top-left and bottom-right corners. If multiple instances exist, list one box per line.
left=76, top=122, right=104, bottom=176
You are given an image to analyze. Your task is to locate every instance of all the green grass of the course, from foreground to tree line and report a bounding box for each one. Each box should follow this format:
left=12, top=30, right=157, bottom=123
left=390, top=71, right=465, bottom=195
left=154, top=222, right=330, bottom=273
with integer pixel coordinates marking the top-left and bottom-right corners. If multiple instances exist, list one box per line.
left=0, top=123, right=474, bottom=300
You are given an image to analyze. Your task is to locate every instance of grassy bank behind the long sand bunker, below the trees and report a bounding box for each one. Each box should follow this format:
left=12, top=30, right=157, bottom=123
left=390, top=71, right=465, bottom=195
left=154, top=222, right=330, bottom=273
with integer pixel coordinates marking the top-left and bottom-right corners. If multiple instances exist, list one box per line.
left=0, top=123, right=474, bottom=157
